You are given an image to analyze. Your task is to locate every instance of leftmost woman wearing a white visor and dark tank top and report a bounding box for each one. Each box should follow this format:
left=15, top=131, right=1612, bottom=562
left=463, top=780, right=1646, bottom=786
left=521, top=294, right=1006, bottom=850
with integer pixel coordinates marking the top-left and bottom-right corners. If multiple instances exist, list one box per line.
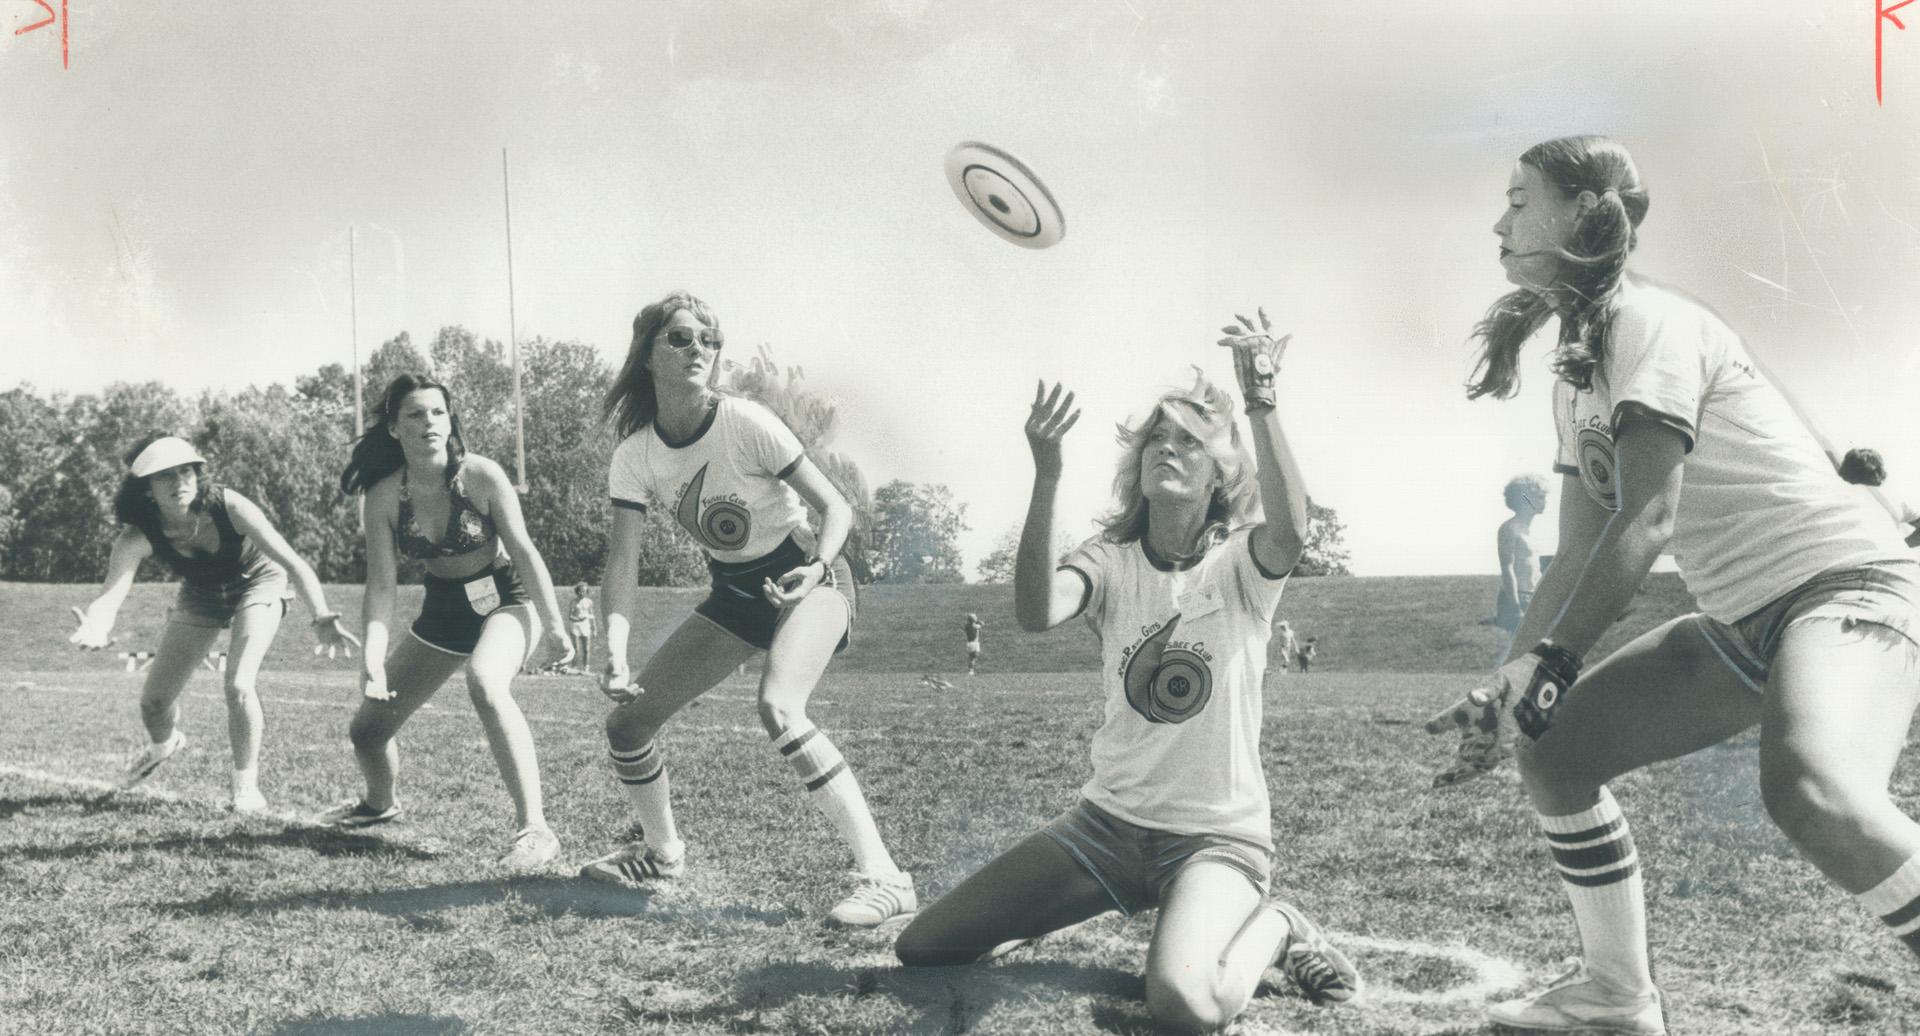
left=67, top=434, right=359, bottom=813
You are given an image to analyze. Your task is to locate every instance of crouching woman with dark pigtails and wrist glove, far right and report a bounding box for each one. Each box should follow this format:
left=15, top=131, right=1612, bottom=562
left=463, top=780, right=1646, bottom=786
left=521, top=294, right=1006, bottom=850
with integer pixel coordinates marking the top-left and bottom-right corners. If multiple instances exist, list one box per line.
left=1428, top=136, right=1920, bottom=1034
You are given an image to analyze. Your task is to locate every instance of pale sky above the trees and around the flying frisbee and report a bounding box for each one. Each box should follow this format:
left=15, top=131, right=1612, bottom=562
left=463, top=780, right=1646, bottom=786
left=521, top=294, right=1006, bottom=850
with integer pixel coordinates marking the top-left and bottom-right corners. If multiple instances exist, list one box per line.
left=0, top=0, right=1920, bottom=574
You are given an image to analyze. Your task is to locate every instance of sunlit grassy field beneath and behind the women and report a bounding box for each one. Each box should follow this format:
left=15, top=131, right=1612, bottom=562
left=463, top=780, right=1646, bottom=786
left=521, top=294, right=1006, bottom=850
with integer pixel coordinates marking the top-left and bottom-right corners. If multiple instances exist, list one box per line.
left=0, top=579, right=1920, bottom=1036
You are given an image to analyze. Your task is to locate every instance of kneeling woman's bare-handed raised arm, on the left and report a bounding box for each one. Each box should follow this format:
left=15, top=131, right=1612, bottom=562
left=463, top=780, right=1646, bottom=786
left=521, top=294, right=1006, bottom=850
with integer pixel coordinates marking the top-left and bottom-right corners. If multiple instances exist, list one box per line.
left=1014, top=382, right=1089, bottom=633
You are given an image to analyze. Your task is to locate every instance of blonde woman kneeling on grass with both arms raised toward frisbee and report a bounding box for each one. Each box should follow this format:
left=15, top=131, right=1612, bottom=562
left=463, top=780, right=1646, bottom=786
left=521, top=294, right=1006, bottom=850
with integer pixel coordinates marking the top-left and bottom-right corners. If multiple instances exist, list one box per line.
left=895, top=313, right=1359, bottom=1030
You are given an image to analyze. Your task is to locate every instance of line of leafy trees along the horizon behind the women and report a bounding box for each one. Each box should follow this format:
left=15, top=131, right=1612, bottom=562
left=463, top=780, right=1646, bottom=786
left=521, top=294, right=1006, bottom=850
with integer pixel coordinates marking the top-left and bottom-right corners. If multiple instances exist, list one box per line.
left=0, top=326, right=1346, bottom=585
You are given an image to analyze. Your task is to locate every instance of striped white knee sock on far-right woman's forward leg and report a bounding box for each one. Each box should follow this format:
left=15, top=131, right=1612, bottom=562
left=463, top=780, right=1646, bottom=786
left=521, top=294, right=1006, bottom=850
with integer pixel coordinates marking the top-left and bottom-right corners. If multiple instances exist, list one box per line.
left=1540, top=789, right=1653, bottom=994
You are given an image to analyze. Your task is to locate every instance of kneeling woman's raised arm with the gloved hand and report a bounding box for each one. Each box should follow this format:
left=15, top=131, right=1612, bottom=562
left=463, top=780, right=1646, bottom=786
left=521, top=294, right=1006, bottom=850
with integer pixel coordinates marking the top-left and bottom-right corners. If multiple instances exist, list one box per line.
left=1219, top=309, right=1309, bottom=574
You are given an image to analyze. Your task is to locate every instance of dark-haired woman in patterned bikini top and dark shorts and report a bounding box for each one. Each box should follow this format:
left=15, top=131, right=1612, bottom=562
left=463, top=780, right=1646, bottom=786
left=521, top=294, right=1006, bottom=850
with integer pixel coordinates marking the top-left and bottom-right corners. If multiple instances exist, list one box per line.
left=323, top=374, right=572, bottom=869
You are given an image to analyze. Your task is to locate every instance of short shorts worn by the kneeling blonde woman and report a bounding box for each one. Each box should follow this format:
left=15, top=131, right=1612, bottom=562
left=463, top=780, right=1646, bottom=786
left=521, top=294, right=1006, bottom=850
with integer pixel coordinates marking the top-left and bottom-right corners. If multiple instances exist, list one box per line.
left=1041, top=798, right=1273, bottom=915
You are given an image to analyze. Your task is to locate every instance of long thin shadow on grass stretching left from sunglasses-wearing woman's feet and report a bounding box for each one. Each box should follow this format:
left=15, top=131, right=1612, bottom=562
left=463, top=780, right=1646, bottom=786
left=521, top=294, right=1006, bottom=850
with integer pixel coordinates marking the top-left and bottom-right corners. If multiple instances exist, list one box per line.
left=154, top=875, right=791, bottom=930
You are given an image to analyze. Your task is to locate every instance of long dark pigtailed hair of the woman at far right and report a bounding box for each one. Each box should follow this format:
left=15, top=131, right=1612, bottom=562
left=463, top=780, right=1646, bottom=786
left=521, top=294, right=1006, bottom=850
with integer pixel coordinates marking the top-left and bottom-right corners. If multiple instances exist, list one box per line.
left=1467, top=134, right=1647, bottom=399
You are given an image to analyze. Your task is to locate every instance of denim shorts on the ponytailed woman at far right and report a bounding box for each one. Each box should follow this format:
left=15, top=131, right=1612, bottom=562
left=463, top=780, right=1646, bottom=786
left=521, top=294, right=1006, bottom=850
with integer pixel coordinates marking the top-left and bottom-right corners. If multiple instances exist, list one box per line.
left=1693, top=558, right=1920, bottom=691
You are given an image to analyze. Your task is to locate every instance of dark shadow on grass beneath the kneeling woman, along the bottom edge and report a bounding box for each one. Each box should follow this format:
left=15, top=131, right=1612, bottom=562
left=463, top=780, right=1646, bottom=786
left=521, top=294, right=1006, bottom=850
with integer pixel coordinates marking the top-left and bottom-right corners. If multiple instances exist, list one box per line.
left=611, top=961, right=1156, bottom=1034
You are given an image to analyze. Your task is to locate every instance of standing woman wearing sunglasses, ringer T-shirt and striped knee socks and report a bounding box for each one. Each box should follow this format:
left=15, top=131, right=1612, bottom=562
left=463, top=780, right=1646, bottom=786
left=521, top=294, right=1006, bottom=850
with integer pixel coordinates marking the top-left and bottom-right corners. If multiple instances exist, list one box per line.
left=580, top=292, right=918, bottom=927
